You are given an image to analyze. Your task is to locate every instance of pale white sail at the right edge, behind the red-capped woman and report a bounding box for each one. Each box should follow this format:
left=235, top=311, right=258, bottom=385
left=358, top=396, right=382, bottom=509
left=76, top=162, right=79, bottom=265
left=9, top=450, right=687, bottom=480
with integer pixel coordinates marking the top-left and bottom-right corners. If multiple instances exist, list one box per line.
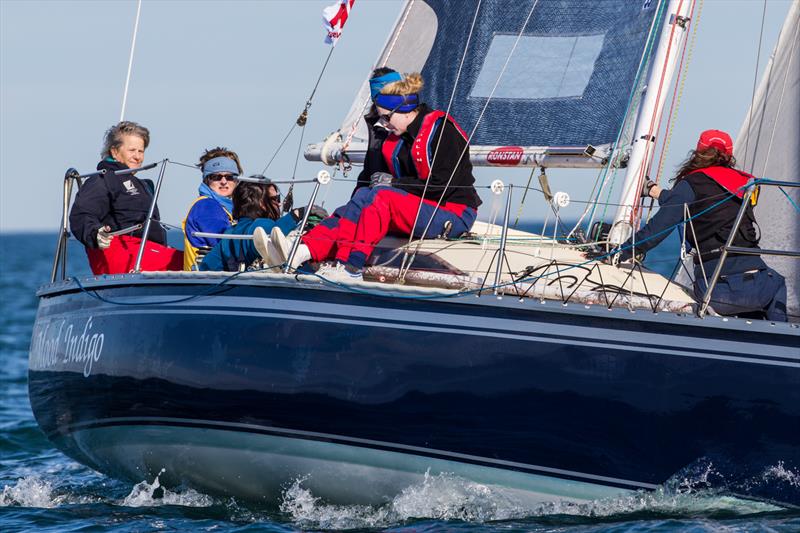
left=734, top=2, right=800, bottom=317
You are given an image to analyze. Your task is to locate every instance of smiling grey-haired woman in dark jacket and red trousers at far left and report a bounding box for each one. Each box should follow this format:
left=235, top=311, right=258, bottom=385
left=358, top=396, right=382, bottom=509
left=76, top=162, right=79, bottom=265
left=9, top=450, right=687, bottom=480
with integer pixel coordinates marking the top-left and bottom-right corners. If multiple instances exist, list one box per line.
left=69, top=121, right=183, bottom=274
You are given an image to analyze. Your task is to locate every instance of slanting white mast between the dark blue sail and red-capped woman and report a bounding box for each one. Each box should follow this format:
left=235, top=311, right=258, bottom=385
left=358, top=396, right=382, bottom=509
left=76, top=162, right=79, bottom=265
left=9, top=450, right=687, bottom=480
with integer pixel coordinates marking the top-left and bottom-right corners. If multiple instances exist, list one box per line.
left=609, top=0, right=694, bottom=244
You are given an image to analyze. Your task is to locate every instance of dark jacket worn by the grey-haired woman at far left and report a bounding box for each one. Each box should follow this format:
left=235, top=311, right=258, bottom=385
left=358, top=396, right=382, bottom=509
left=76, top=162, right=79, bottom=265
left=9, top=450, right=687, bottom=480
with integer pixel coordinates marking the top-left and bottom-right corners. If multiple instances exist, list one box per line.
left=69, top=160, right=167, bottom=248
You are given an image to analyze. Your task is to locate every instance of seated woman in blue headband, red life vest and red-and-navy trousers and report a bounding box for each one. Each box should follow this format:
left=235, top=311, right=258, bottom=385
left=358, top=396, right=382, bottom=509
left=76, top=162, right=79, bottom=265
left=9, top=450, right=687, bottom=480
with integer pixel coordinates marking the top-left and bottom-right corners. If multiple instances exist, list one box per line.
left=256, top=74, right=481, bottom=280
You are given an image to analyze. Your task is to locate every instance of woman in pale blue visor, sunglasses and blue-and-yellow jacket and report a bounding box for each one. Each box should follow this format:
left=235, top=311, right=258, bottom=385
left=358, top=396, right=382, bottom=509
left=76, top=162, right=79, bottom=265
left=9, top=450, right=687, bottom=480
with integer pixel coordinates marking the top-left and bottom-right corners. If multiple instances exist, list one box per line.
left=183, top=147, right=242, bottom=270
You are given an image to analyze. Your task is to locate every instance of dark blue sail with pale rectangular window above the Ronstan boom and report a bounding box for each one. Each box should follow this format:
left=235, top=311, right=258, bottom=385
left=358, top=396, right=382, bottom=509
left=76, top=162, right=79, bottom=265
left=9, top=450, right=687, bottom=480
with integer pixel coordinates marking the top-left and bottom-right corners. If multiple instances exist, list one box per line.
left=341, top=0, right=664, bottom=153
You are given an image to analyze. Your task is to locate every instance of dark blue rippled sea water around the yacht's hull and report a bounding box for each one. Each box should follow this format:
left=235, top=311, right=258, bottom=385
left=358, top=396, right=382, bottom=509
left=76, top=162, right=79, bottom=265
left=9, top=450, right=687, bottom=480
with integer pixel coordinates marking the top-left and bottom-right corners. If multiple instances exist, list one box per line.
left=0, top=230, right=800, bottom=532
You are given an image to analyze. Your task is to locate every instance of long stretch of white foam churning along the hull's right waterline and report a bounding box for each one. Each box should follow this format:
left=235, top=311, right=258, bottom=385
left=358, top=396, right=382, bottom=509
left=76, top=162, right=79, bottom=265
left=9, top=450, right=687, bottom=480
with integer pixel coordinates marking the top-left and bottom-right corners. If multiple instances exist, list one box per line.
left=280, top=464, right=784, bottom=529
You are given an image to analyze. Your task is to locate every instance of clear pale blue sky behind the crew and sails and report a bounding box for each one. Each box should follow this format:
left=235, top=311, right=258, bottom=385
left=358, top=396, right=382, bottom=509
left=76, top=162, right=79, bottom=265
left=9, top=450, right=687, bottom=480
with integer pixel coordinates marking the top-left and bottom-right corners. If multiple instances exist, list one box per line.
left=0, top=0, right=789, bottom=231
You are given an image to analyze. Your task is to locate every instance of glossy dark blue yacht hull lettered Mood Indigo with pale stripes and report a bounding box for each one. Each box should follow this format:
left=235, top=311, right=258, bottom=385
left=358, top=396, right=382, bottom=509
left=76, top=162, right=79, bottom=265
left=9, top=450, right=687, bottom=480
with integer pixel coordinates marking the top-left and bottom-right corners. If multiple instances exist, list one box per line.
left=30, top=278, right=800, bottom=504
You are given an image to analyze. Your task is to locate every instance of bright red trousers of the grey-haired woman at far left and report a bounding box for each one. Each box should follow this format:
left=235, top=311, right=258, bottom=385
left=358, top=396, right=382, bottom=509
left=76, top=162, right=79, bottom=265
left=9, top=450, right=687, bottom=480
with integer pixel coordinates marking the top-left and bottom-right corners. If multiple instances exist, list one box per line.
left=86, top=235, right=183, bottom=275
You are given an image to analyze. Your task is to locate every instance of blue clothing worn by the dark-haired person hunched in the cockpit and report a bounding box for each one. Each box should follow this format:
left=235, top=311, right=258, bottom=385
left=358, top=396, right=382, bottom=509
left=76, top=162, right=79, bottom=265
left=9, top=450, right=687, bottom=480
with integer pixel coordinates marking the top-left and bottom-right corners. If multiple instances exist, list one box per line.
left=199, top=214, right=297, bottom=272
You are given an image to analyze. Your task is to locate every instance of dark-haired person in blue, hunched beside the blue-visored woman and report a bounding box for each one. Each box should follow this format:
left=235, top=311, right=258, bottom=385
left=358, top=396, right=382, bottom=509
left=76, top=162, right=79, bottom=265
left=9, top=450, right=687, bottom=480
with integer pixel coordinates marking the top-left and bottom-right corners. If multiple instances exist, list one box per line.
left=198, top=175, right=328, bottom=272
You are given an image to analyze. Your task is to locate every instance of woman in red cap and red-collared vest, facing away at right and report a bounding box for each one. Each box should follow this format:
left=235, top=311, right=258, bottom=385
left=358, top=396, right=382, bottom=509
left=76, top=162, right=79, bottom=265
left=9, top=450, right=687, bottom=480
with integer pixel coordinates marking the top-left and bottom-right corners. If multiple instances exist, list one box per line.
left=620, top=130, right=787, bottom=322
